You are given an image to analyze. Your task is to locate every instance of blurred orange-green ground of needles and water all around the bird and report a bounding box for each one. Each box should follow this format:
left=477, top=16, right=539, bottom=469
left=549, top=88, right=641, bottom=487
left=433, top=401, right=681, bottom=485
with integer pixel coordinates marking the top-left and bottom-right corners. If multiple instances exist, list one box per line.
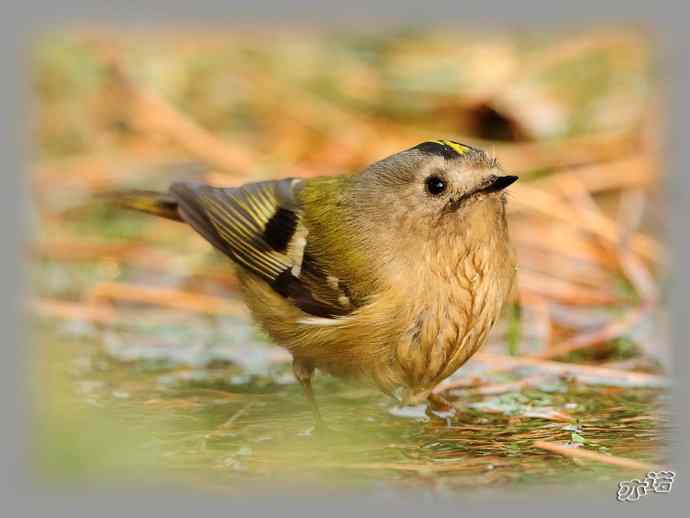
left=27, top=27, right=670, bottom=495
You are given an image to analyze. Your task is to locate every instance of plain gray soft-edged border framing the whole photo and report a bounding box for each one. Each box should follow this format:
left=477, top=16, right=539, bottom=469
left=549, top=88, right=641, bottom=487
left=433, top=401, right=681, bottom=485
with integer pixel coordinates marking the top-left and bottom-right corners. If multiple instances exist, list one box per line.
left=0, top=0, right=690, bottom=517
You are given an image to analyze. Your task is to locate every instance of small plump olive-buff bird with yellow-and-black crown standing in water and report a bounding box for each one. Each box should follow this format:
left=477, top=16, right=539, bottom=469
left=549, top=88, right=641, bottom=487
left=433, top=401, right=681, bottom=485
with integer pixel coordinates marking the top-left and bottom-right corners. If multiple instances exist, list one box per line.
left=109, top=139, right=518, bottom=424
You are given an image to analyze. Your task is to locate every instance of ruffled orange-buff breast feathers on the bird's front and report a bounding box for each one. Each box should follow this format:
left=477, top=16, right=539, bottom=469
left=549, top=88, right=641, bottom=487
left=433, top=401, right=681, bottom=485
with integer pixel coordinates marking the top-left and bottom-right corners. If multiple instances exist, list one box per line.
left=395, top=233, right=515, bottom=402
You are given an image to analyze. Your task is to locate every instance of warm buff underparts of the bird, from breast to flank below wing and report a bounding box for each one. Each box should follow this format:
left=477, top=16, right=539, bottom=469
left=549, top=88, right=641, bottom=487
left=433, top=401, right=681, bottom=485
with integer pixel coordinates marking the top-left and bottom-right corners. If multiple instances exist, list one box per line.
left=236, top=242, right=514, bottom=403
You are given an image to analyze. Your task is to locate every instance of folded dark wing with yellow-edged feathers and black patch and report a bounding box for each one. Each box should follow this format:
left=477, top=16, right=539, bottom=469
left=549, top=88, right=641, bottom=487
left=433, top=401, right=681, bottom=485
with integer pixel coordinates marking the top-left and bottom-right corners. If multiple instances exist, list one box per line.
left=170, top=178, right=354, bottom=318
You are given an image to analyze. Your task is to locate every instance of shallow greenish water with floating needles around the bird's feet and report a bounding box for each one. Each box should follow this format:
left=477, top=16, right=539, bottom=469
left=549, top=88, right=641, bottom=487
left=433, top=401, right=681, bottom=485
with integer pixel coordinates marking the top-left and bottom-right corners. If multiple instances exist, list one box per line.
left=33, top=316, right=668, bottom=495
